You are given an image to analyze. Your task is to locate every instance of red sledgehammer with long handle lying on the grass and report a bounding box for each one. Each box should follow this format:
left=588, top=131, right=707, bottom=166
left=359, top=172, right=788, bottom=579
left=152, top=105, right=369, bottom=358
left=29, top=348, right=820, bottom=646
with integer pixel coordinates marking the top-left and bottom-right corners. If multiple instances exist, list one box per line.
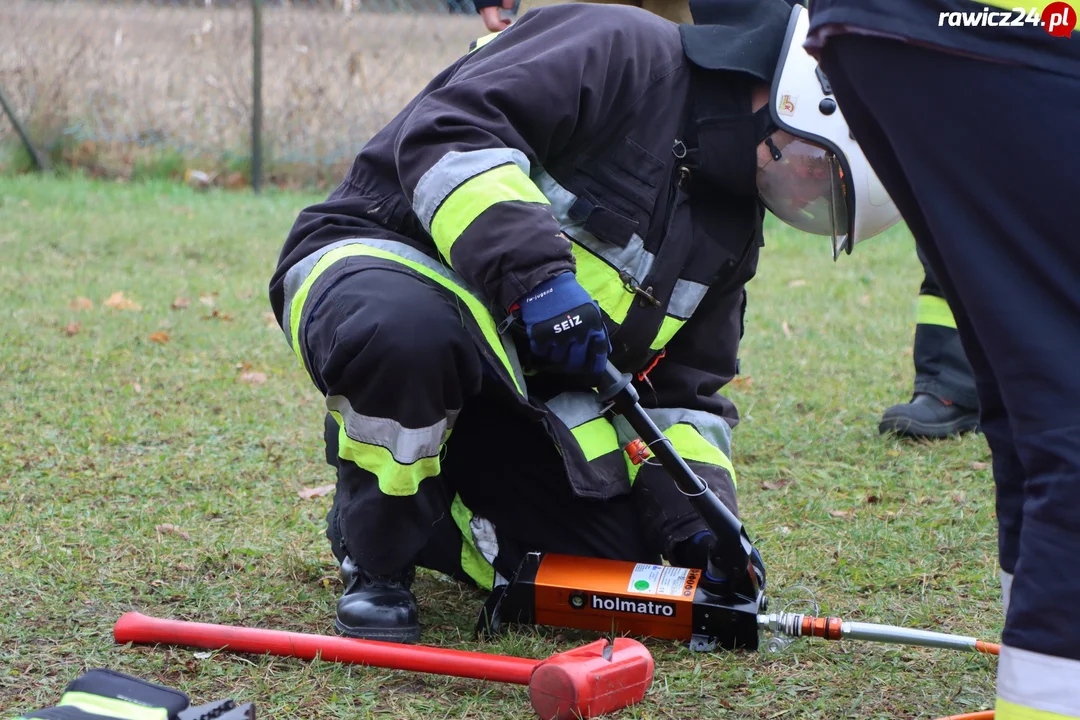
left=119, top=612, right=653, bottom=720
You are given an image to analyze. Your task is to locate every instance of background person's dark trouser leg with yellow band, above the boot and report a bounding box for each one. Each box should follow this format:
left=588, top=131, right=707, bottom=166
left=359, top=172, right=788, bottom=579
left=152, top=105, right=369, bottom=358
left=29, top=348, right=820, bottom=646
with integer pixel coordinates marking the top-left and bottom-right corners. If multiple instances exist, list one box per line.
left=913, top=247, right=978, bottom=409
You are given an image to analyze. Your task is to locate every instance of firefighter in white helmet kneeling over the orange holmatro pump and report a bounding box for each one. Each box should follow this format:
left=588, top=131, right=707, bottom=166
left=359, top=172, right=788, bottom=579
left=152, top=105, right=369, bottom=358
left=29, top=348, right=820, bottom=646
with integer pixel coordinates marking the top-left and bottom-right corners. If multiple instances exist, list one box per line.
left=270, top=0, right=897, bottom=642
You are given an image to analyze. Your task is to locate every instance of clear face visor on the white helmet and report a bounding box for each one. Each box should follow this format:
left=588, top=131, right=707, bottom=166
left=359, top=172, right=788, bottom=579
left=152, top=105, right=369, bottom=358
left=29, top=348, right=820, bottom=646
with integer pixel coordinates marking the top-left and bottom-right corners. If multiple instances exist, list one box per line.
left=757, top=133, right=850, bottom=246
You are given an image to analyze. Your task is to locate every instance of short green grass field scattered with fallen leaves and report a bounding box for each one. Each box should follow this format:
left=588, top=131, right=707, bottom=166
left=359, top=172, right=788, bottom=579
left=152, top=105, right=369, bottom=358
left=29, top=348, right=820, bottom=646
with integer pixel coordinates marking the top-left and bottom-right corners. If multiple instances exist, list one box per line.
left=0, top=177, right=1002, bottom=720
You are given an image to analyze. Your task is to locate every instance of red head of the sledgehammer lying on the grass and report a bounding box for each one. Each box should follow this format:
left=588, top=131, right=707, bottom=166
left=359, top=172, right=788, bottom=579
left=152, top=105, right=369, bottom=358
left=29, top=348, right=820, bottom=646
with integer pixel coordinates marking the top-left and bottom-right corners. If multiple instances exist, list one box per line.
left=529, top=638, right=653, bottom=720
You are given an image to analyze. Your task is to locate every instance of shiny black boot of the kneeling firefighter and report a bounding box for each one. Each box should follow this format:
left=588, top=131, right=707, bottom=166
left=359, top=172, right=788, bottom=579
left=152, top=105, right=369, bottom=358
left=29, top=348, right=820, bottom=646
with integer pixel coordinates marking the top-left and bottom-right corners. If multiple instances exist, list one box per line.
left=334, top=557, right=420, bottom=642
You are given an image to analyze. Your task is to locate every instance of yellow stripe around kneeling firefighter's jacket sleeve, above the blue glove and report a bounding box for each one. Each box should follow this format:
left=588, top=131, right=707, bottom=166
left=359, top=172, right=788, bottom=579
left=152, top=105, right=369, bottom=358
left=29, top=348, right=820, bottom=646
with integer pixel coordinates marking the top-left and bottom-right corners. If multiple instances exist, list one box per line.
left=431, top=165, right=551, bottom=268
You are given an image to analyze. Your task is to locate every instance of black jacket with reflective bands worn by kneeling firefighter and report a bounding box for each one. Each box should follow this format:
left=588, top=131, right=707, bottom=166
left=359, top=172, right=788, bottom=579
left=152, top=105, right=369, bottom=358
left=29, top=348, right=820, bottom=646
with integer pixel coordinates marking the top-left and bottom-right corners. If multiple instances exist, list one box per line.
left=270, top=3, right=764, bottom=546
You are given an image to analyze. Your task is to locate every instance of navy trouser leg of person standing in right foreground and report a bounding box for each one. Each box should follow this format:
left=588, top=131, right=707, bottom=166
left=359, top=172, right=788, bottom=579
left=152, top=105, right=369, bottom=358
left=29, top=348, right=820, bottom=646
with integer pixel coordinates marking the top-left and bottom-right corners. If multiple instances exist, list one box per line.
left=822, top=36, right=1080, bottom=720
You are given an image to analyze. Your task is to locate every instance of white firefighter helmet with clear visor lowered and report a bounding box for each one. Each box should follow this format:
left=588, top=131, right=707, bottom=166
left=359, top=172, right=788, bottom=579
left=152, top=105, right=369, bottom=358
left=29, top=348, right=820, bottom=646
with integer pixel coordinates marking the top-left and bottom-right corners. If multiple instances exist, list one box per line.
left=757, top=3, right=900, bottom=260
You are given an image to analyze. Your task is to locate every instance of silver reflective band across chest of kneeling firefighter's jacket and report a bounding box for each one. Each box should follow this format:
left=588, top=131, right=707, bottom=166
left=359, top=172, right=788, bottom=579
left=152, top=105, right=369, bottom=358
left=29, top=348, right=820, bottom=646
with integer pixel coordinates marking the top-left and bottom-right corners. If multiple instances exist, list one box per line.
left=532, top=169, right=708, bottom=320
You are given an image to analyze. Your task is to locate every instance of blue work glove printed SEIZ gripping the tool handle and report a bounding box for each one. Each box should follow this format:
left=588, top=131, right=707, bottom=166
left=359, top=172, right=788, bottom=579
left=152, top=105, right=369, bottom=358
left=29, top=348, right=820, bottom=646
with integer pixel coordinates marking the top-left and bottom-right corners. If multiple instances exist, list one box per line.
left=516, top=272, right=611, bottom=380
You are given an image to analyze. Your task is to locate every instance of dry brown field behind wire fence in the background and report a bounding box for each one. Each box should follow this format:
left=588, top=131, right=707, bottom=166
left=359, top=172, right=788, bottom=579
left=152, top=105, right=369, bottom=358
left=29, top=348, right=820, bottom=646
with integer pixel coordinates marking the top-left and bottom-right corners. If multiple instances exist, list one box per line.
left=0, top=0, right=486, bottom=188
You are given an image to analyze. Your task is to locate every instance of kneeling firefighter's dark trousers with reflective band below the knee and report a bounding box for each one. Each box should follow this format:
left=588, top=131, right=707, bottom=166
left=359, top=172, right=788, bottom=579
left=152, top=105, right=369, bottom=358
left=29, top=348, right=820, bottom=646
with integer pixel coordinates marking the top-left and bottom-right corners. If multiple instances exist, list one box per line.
left=301, top=250, right=660, bottom=589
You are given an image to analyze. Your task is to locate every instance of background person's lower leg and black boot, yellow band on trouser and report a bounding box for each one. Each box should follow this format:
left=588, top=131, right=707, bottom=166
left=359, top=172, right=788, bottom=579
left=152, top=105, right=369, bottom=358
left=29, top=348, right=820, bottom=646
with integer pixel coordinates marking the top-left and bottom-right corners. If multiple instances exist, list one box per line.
left=878, top=247, right=978, bottom=437
